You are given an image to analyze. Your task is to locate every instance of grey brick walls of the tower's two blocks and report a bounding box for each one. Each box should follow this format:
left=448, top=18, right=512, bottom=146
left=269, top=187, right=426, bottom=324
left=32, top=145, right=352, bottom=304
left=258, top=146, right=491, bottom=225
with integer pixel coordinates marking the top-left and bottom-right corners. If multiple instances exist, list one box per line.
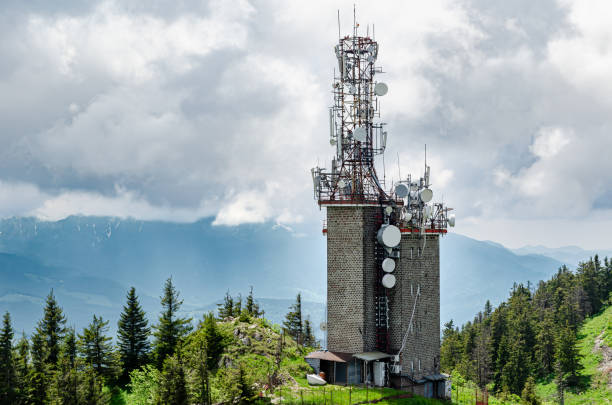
left=327, top=206, right=440, bottom=379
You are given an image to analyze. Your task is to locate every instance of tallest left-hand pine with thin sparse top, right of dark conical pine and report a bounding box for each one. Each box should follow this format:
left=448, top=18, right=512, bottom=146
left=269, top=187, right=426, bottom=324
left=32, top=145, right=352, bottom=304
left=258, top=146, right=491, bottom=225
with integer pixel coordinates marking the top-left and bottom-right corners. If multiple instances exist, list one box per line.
left=154, top=278, right=192, bottom=369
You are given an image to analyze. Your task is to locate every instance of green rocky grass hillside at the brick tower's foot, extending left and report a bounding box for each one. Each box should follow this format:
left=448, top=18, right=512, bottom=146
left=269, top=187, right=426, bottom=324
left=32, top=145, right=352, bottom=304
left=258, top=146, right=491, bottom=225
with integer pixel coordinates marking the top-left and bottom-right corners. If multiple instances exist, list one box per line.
left=111, top=318, right=442, bottom=405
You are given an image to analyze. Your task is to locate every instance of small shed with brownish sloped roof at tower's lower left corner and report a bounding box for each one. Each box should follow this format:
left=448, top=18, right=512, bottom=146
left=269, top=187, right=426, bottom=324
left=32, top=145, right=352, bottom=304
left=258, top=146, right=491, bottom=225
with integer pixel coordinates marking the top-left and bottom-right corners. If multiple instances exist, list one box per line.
left=305, top=350, right=363, bottom=384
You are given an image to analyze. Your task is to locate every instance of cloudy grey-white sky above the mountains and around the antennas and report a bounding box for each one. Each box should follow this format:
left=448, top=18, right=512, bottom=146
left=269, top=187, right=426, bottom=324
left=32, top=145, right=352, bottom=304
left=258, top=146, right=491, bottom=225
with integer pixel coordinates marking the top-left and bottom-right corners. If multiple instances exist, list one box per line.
left=0, top=0, right=612, bottom=248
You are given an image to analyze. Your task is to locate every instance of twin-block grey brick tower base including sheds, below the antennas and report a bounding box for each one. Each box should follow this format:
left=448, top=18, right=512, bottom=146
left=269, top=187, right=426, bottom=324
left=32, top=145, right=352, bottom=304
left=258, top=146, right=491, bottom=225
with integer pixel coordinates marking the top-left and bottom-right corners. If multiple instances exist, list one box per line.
left=307, top=205, right=450, bottom=398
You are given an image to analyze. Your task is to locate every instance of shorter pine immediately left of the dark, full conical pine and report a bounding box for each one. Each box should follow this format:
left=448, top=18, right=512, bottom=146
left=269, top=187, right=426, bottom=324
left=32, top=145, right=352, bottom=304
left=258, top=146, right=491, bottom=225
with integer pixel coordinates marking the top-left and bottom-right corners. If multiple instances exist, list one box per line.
left=79, top=315, right=115, bottom=377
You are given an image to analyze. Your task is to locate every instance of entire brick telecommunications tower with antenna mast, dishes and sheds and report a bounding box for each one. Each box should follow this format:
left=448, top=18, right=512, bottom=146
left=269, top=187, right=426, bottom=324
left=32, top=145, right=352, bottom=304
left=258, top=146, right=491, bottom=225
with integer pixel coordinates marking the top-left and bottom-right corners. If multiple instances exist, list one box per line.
left=307, top=19, right=454, bottom=396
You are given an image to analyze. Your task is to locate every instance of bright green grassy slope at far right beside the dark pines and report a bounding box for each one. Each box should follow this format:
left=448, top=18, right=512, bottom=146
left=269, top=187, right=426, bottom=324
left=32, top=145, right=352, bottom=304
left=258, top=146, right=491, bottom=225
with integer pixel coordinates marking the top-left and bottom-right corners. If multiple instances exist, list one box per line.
left=536, top=307, right=612, bottom=405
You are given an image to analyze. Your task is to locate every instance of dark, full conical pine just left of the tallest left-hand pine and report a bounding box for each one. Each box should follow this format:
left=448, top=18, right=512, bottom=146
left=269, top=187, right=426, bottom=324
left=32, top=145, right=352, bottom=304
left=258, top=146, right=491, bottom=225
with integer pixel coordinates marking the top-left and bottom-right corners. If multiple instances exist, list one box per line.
left=117, top=287, right=151, bottom=382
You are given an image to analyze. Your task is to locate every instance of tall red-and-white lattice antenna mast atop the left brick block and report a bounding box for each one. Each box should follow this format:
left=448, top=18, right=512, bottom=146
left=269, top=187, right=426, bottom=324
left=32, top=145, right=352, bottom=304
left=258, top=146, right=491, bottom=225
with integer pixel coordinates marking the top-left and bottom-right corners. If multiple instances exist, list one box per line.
left=312, top=9, right=389, bottom=205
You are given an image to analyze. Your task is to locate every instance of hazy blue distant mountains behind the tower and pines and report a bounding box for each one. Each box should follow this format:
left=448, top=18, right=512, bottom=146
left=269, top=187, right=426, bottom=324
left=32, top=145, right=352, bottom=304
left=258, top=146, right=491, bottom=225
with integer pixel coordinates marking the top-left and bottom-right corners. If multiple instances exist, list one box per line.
left=0, top=217, right=561, bottom=332
